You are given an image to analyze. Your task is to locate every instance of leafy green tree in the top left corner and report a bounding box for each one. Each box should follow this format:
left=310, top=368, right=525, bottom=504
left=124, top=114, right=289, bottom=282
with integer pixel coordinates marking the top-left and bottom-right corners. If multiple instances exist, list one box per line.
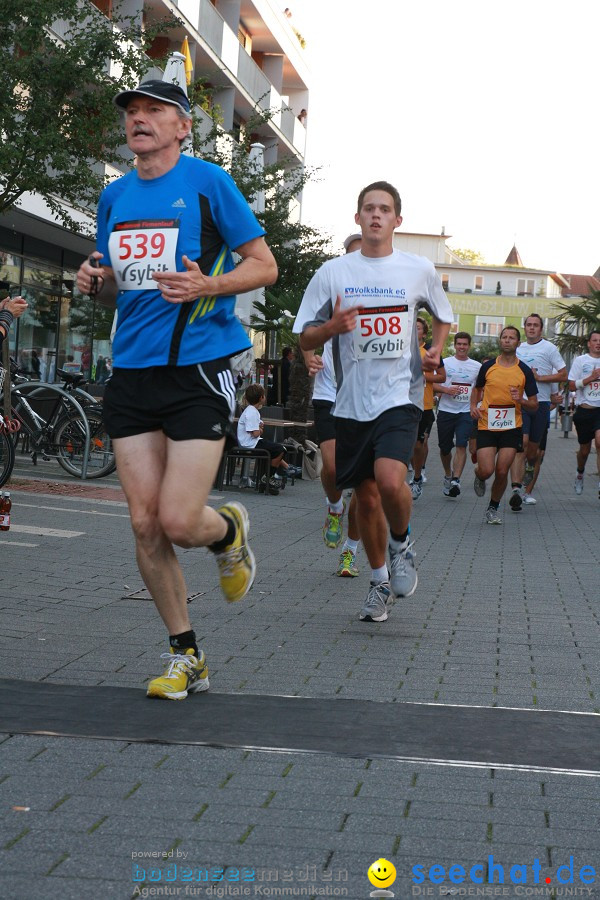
left=0, top=0, right=174, bottom=231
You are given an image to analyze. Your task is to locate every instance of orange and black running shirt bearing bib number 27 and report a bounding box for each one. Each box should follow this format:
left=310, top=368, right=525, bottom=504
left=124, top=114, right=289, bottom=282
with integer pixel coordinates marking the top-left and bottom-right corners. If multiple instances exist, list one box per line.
left=475, top=359, right=538, bottom=431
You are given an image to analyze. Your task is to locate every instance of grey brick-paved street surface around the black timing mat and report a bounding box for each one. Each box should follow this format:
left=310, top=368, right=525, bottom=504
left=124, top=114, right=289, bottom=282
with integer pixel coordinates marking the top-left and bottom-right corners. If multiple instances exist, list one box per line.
left=0, top=431, right=600, bottom=900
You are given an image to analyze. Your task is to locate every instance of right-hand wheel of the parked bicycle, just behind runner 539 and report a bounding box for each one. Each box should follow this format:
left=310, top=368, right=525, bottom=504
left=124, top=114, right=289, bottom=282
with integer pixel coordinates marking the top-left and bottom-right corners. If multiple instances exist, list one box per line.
left=54, top=410, right=116, bottom=478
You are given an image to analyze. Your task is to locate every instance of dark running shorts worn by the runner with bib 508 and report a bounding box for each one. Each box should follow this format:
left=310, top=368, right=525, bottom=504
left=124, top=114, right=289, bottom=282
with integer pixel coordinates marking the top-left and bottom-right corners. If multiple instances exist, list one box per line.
left=335, top=404, right=421, bottom=490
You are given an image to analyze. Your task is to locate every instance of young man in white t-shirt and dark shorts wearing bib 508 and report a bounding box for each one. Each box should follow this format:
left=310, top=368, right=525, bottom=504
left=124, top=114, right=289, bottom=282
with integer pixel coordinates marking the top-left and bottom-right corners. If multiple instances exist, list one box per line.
left=299, top=181, right=452, bottom=622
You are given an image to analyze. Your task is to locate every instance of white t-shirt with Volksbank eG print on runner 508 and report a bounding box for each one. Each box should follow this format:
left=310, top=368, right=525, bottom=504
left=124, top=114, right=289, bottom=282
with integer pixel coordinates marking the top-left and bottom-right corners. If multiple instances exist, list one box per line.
left=294, top=250, right=453, bottom=422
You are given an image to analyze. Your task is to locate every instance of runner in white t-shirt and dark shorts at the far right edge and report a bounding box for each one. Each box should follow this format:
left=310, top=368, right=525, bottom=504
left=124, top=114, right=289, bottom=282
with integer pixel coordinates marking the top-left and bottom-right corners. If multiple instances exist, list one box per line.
left=569, top=330, right=600, bottom=498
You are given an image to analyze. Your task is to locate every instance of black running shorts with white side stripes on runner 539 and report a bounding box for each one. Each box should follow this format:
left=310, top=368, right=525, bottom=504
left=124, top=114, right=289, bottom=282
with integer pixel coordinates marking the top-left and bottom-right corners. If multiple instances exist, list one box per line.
left=104, top=357, right=235, bottom=441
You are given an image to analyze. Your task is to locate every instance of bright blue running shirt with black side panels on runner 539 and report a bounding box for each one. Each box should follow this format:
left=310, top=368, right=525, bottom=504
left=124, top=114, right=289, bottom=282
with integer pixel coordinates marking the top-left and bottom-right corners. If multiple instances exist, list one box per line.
left=97, top=155, right=265, bottom=369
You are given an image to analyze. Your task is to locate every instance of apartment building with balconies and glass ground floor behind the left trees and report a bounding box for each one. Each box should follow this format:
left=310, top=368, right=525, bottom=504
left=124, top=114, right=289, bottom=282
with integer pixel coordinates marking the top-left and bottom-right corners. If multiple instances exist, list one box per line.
left=0, top=0, right=309, bottom=381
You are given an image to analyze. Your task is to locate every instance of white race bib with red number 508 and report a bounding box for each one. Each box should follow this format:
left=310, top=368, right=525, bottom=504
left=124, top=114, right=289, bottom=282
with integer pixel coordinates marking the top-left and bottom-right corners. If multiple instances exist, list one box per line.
left=354, top=305, right=410, bottom=359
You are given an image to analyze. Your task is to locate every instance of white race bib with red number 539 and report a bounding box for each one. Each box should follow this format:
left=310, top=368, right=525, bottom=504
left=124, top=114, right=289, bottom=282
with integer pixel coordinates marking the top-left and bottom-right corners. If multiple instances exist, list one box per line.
left=108, top=219, right=179, bottom=291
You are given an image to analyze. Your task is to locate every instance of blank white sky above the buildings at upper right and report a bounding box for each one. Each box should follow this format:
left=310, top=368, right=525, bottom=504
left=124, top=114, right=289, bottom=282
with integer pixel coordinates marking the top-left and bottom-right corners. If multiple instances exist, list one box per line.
left=290, top=0, right=600, bottom=274
